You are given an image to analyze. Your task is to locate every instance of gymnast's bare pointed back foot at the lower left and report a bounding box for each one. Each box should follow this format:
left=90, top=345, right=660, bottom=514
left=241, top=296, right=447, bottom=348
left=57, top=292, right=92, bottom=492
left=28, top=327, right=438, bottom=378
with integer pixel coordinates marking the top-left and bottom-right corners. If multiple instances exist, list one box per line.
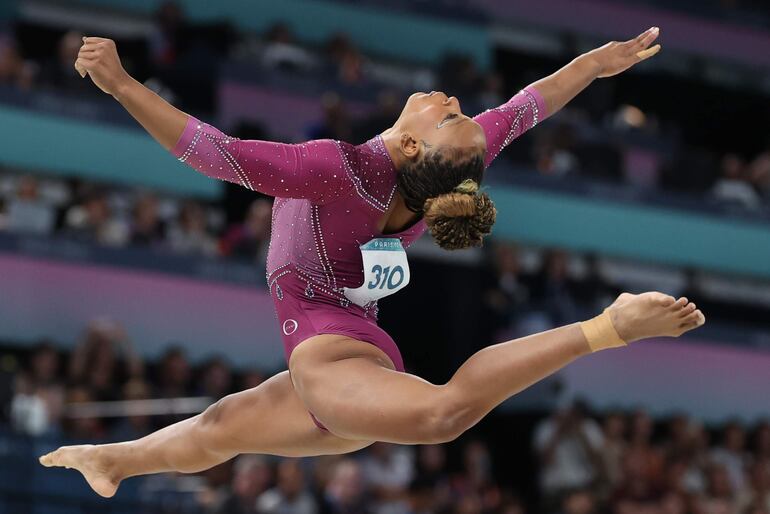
left=40, top=445, right=120, bottom=498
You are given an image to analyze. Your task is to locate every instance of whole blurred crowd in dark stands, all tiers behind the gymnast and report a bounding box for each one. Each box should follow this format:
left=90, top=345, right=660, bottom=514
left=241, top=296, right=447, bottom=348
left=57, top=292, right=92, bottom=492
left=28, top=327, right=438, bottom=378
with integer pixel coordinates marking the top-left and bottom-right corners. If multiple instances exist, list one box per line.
left=0, top=0, right=770, bottom=514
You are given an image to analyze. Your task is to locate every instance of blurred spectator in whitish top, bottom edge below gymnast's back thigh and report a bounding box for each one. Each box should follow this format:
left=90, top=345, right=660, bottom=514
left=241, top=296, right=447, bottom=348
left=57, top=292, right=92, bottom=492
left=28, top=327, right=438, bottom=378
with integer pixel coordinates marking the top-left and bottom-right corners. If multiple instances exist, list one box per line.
left=257, top=459, right=318, bottom=514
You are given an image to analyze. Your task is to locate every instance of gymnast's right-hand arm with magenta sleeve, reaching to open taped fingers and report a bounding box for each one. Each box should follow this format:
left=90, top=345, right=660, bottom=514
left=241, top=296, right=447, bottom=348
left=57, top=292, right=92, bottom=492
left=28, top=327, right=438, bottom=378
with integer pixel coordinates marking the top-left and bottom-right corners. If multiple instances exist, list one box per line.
left=473, top=27, right=660, bottom=166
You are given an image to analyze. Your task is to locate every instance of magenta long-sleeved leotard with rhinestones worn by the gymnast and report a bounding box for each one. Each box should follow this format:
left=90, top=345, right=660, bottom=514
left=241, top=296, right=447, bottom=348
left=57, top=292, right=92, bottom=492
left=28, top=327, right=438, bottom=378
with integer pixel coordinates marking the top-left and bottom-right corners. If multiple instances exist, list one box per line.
left=172, top=87, right=546, bottom=371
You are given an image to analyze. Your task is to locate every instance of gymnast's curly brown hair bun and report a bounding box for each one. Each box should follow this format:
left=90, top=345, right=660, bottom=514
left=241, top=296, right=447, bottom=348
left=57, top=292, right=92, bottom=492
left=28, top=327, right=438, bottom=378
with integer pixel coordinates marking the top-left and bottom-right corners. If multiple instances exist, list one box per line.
left=424, top=190, right=497, bottom=250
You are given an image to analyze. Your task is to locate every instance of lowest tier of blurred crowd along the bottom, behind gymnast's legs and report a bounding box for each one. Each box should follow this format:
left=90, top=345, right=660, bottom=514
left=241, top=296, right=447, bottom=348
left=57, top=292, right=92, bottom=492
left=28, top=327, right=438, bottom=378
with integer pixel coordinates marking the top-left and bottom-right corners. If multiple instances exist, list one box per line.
left=2, top=319, right=770, bottom=514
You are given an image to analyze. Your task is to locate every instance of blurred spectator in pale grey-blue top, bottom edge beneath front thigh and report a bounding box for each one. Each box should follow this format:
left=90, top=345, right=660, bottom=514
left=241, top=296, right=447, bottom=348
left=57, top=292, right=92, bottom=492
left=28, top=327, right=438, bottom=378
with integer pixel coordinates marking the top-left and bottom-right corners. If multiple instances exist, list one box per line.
left=361, top=442, right=414, bottom=514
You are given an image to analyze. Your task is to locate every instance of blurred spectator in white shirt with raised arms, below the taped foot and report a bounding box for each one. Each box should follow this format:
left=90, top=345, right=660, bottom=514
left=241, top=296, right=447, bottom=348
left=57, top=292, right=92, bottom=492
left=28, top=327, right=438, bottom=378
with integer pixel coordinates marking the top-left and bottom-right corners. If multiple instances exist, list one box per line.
left=534, top=401, right=604, bottom=510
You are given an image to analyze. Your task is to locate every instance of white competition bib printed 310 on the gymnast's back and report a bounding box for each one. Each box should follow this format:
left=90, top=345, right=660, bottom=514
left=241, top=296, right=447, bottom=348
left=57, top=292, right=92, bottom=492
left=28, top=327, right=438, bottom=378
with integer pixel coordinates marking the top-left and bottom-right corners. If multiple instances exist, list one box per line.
left=343, top=237, right=409, bottom=307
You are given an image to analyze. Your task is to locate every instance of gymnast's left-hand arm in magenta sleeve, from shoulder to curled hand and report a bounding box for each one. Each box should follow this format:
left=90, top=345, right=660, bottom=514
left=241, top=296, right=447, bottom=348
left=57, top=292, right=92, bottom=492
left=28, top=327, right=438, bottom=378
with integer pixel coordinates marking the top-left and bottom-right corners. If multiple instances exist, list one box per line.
left=75, top=37, right=351, bottom=203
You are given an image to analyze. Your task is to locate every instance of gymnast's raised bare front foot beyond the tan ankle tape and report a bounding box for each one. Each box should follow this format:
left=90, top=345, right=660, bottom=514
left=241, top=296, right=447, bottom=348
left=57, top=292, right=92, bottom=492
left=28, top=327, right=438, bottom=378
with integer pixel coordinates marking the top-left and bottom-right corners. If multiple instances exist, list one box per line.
left=608, top=292, right=706, bottom=343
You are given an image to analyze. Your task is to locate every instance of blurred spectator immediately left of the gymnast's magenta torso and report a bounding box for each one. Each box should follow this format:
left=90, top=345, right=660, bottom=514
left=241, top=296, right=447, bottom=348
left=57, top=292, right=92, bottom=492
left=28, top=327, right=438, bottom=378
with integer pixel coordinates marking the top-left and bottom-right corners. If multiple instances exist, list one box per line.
left=220, top=198, right=273, bottom=264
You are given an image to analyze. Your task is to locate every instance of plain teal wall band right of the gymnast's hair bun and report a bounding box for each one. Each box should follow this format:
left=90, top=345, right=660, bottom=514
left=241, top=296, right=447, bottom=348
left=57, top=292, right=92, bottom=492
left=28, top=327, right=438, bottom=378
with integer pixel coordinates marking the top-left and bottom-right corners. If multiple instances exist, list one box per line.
left=490, top=186, right=770, bottom=278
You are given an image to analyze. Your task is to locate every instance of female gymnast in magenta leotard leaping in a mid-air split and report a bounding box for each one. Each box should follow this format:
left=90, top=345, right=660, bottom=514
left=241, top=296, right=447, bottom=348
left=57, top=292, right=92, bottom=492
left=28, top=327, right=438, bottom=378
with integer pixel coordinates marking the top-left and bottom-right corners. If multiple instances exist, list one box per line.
left=40, top=27, right=705, bottom=497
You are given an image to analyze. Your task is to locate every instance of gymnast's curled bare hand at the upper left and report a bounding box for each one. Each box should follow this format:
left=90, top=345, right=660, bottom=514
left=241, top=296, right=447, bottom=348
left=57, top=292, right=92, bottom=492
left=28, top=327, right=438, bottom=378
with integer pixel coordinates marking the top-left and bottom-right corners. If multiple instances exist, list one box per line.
left=75, top=37, right=131, bottom=96
